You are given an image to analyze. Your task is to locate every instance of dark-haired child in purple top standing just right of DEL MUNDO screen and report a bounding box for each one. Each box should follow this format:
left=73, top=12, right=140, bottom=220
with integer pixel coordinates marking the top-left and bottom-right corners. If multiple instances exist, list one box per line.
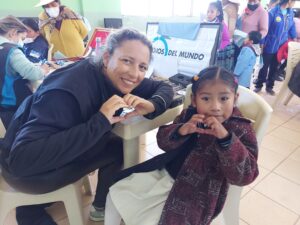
left=206, top=1, right=230, bottom=49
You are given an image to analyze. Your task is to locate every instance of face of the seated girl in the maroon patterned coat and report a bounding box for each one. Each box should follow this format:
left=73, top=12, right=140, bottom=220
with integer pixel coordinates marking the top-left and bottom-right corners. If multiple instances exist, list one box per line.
left=192, top=79, right=238, bottom=123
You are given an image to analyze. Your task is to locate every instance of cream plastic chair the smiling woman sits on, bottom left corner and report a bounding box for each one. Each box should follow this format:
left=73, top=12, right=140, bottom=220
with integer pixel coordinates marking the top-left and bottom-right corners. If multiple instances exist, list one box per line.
left=0, top=120, right=90, bottom=225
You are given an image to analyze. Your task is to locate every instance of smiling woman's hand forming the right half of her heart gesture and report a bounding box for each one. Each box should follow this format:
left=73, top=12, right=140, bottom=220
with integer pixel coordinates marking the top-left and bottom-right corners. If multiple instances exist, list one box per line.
left=123, top=94, right=155, bottom=118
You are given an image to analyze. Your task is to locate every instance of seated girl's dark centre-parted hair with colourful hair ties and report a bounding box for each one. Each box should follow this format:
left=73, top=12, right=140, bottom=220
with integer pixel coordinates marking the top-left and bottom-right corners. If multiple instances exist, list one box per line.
left=192, top=66, right=238, bottom=95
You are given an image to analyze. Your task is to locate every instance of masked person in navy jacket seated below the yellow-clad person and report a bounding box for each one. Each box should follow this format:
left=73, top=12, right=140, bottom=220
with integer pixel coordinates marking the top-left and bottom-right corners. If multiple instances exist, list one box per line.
left=22, top=18, right=48, bottom=63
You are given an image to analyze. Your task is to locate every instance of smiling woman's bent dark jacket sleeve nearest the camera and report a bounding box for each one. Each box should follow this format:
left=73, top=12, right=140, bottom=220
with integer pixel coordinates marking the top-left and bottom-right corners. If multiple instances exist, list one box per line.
left=8, top=91, right=112, bottom=176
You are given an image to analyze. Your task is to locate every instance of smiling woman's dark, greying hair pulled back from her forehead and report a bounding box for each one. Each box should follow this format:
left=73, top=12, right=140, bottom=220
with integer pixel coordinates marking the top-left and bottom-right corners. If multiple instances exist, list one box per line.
left=105, top=28, right=153, bottom=59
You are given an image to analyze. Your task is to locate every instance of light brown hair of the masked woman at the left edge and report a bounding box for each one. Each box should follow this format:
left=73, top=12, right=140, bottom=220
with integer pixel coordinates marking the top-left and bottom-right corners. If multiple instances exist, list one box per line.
left=0, top=16, right=27, bottom=35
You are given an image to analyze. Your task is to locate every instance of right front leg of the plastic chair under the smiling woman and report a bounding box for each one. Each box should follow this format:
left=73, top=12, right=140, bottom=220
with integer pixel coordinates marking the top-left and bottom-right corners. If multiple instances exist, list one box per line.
left=64, top=185, right=85, bottom=225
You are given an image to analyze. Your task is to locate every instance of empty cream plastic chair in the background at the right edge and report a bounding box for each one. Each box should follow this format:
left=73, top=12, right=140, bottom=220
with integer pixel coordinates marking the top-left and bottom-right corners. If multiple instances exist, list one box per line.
left=272, top=42, right=300, bottom=109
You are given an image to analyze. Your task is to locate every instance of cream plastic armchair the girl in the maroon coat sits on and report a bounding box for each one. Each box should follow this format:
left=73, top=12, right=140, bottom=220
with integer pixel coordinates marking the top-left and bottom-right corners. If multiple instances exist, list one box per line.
left=184, top=85, right=273, bottom=225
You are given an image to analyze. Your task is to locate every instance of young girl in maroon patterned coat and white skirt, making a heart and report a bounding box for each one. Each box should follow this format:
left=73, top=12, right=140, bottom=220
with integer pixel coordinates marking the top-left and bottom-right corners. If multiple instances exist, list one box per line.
left=105, top=66, right=258, bottom=225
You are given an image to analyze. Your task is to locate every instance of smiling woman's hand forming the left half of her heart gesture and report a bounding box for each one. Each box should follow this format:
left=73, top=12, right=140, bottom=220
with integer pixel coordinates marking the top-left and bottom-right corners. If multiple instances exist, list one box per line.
left=99, top=95, right=128, bottom=124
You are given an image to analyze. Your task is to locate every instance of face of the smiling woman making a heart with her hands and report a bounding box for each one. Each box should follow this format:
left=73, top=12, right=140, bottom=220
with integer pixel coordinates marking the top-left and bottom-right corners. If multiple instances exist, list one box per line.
left=103, top=40, right=150, bottom=94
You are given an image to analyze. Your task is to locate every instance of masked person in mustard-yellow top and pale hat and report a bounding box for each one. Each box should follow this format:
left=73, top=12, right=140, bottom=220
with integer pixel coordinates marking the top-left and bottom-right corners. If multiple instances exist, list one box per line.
left=35, top=0, right=88, bottom=57
